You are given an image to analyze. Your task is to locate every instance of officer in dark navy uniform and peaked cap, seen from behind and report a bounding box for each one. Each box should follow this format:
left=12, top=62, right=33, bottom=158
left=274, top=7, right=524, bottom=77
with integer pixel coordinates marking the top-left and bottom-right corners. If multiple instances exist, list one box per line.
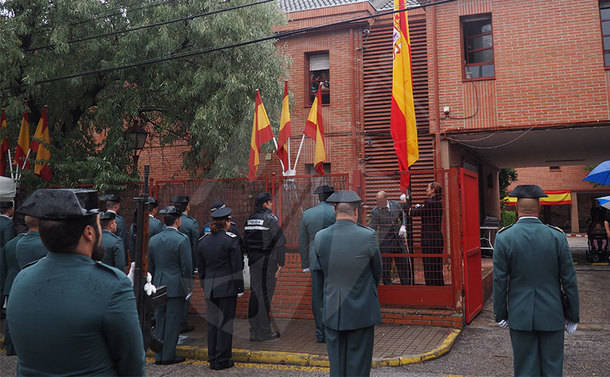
left=197, top=206, right=244, bottom=370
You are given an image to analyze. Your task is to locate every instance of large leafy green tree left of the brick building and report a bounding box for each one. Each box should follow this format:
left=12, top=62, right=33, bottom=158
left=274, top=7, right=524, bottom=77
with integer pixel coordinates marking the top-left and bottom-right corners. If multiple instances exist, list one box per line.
left=0, top=0, right=288, bottom=189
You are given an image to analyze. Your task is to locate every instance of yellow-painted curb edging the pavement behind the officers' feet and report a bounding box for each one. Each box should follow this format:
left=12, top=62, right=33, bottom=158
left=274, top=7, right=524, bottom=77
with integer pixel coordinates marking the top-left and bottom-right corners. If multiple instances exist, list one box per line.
left=162, top=329, right=462, bottom=368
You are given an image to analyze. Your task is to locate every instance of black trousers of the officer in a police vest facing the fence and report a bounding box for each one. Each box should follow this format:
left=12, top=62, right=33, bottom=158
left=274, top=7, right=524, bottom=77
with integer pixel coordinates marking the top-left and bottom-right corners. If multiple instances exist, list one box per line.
left=248, top=255, right=277, bottom=337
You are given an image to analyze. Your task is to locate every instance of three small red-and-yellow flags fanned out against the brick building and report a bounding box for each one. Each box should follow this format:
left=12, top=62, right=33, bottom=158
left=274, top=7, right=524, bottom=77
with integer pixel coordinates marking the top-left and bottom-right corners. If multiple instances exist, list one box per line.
left=248, top=81, right=326, bottom=181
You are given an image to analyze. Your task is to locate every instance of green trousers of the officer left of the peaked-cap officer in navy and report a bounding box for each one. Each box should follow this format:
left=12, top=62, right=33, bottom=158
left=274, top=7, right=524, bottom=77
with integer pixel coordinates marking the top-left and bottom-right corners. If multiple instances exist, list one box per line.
left=155, top=297, right=184, bottom=361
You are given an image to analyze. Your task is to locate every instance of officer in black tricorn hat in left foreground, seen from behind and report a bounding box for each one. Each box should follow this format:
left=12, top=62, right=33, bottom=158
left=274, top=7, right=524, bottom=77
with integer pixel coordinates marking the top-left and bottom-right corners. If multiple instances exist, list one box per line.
left=8, top=189, right=145, bottom=376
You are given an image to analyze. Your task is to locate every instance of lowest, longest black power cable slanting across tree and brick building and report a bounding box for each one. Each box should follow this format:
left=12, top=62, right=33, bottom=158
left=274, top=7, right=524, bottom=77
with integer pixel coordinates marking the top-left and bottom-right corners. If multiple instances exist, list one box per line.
left=30, top=0, right=456, bottom=85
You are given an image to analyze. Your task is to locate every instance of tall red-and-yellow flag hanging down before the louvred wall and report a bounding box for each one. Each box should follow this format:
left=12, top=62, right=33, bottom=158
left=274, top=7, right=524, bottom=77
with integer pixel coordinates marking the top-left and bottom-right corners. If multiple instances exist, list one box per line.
left=390, top=0, right=419, bottom=192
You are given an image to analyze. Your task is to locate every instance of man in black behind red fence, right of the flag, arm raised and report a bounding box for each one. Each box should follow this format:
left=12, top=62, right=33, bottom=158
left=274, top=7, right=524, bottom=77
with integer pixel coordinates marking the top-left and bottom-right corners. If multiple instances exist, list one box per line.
left=409, top=182, right=444, bottom=285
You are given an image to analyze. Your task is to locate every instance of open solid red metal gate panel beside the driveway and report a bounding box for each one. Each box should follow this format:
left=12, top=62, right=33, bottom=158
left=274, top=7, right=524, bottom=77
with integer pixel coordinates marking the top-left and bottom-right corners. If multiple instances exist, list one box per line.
left=460, top=169, right=483, bottom=323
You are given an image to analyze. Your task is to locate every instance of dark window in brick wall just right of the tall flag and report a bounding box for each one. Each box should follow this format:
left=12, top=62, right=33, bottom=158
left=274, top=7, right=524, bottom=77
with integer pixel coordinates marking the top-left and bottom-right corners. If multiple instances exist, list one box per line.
left=462, top=14, right=496, bottom=79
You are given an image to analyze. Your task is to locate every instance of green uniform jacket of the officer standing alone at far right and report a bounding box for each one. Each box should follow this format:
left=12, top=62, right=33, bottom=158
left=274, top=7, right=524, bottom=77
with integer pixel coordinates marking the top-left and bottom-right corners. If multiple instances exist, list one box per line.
left=493, top=218, right=579, bottom=331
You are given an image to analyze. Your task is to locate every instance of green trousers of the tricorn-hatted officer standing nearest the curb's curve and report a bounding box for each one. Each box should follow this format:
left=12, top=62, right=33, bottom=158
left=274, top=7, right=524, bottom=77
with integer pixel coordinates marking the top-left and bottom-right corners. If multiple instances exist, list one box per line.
left=326, top=326, right=375, bottom=377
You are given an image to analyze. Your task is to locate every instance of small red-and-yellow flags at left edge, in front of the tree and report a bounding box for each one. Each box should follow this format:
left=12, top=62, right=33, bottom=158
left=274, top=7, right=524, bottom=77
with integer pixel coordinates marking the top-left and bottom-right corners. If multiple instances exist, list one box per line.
left=0, top=106, right=53, bottom=182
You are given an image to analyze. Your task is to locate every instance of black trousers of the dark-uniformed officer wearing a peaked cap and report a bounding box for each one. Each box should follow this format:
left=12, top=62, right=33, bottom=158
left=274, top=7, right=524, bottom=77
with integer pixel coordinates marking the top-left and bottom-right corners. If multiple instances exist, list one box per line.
left=205, top=296, right=237, bottom=367
